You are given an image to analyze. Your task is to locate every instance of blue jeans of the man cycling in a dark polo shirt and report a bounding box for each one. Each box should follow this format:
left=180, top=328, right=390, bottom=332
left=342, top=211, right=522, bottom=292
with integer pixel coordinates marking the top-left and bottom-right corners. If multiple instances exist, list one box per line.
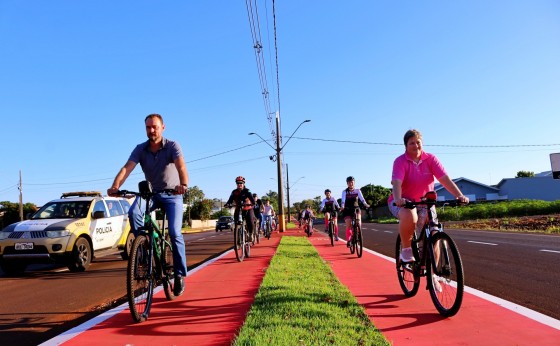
left=128, top=193, right=187, bottom=276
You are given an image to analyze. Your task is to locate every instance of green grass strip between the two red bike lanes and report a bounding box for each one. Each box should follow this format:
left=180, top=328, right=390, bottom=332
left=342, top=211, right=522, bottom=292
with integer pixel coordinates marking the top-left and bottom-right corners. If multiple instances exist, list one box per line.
left=234, top=237, right=389, bottom=345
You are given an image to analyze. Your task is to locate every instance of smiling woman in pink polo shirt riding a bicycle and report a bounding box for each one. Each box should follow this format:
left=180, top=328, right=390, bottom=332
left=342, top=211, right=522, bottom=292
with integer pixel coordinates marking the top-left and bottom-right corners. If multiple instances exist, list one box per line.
left=388, top=130, right=469, bottom=262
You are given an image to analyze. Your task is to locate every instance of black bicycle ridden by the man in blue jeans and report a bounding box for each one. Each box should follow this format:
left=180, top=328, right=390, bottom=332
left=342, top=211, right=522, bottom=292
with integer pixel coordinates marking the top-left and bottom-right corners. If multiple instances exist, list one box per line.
left=117, top=181, right=176, bottom=322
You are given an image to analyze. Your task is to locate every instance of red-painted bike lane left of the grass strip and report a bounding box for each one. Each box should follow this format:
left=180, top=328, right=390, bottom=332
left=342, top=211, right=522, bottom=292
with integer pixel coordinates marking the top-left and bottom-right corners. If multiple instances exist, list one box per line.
left=55, top=235, right=280, bottom=346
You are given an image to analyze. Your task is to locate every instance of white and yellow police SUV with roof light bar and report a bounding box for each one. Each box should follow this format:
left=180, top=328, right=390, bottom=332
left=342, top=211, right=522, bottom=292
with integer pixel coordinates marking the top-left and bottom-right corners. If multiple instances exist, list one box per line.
left=0, top=191, right=134, bottom=275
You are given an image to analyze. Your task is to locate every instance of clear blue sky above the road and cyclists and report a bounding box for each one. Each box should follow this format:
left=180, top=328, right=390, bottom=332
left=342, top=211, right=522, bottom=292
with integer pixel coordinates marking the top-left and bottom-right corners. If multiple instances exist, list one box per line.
left=0, top=0, right=560, bottom=205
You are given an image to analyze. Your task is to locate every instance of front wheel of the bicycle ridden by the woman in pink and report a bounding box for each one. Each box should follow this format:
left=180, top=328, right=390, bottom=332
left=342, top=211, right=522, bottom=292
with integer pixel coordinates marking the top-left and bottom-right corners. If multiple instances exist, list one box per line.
left=427, top=232, right=464, bottom=317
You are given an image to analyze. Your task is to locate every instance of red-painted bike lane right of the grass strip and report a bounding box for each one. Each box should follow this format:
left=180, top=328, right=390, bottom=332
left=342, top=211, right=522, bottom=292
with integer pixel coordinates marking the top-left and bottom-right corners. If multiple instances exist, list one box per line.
left=310, top=232, right=560, bottom=346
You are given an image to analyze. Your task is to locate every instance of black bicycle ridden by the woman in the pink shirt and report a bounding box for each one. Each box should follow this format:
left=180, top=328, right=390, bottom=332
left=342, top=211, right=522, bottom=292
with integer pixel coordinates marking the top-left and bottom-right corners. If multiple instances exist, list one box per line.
left=395, top=191, right=464, bottom=317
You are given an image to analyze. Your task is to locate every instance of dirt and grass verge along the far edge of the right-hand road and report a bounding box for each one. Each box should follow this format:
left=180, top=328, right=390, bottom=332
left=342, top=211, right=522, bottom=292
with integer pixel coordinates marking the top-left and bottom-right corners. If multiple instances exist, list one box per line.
left=445, top=214, right=560, bottom=234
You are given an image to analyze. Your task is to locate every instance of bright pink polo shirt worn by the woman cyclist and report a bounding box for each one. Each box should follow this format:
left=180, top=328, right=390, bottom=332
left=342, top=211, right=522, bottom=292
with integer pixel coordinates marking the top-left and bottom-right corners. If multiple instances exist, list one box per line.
left=388, top=151, right=447, bottom=204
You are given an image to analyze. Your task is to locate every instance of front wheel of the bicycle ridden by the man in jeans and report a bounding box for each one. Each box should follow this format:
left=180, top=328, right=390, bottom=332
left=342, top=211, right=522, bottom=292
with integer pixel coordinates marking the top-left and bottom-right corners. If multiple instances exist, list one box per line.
left=126, top=235, right=154, bottom=322
